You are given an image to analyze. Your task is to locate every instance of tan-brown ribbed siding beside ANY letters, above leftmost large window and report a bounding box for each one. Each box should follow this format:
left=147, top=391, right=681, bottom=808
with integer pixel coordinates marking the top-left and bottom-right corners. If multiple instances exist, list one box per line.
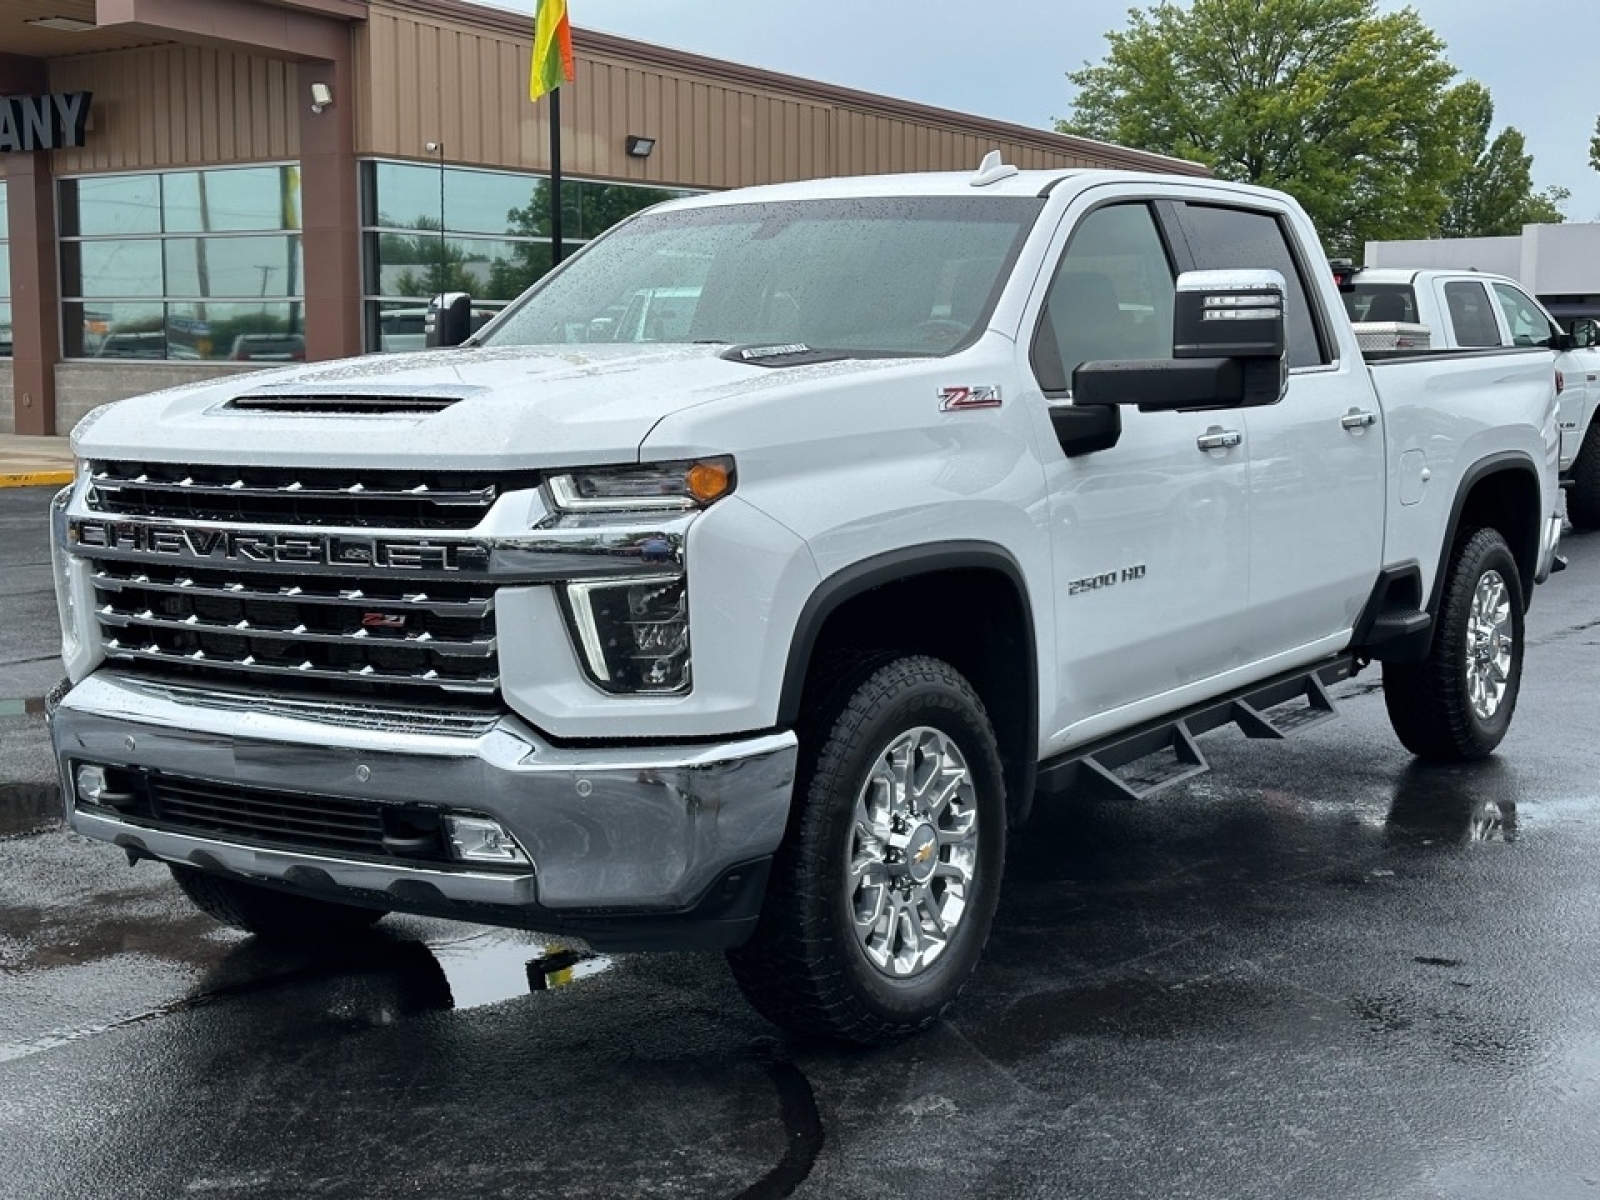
left=50, top=46, right=299, bottom=174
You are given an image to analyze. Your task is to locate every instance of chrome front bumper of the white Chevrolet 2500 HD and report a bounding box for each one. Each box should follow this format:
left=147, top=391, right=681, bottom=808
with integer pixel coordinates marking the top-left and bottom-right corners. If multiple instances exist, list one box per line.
left=51, top=670, right=797, bottom=944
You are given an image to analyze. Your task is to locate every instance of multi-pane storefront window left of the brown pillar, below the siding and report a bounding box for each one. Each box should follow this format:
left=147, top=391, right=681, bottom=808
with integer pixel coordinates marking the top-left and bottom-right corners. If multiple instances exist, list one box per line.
left=59, top=163, right=306, bottom=362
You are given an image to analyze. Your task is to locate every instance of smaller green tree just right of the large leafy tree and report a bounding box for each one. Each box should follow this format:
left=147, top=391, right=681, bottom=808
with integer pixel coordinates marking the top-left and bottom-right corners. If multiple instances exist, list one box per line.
left=1438, top=83, right=1570, bottom=237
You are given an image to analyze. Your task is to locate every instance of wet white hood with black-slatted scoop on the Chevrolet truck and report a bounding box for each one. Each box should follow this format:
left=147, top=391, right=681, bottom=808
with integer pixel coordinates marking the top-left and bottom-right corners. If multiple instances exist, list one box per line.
left=72, top=346, right=867, bottom=470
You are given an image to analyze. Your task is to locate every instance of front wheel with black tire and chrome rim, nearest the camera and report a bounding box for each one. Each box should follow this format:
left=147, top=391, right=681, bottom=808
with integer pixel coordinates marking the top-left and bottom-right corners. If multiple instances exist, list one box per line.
left=728, top=656, right=1006, bottom=1045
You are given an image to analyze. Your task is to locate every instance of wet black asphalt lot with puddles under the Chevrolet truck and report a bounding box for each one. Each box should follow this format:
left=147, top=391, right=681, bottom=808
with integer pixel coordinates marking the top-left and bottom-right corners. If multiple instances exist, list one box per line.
left=0, top=490, right=1600, bottom=1200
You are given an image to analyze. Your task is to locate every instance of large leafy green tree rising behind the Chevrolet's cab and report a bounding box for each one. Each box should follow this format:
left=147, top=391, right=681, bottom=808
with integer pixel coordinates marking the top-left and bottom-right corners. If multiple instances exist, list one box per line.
left=1058, top=0, right=1482, bottom=254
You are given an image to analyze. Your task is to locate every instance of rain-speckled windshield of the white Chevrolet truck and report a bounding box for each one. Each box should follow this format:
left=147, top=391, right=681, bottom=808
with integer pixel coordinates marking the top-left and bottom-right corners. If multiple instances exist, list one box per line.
left=482, top=197, right=1043, bottom=355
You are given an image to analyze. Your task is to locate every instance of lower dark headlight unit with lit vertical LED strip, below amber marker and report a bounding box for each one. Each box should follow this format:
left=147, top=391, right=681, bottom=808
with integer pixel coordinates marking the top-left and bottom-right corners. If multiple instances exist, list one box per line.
left=566, top=574, right=690, bottom=694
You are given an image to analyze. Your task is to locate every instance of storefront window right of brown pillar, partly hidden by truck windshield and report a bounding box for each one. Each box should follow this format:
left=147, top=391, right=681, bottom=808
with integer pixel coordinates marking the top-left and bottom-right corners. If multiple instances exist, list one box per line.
left=362, top=162, right=691, bottom=352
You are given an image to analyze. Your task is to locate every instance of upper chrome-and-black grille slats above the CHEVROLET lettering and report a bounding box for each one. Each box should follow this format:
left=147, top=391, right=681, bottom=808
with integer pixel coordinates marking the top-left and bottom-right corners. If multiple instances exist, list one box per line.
left=88, top=462, right=538, bottom=530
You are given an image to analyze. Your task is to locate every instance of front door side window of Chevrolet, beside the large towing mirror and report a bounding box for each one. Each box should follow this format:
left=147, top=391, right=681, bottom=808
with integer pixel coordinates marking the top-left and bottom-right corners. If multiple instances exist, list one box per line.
left=1032, top=203, right=1174, bottom=392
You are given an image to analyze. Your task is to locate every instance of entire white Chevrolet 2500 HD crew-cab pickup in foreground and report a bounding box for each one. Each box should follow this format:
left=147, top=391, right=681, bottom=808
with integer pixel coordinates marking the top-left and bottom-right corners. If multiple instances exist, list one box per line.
left=51, top=160, right=1560, bottom=1042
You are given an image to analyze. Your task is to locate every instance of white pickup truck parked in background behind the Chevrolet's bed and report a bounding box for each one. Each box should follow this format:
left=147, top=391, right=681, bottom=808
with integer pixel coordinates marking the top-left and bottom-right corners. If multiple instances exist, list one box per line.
left=1336, top=267, right=1600, bottom=530
